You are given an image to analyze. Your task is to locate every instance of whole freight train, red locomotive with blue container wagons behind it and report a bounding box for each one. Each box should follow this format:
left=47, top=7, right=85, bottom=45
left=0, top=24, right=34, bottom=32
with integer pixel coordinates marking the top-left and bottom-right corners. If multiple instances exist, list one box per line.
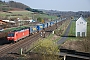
left=7, top=20, right=60, bottom=42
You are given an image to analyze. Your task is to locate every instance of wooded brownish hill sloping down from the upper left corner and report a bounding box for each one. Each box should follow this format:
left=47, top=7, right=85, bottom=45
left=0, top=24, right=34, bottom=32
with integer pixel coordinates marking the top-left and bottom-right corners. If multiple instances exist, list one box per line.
left=0, top=0, right=43, bottom=13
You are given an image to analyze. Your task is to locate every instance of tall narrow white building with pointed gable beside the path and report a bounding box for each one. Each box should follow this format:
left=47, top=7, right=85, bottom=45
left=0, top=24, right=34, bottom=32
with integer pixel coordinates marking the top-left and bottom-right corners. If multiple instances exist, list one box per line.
left=76, top=16, right=87, bottom=37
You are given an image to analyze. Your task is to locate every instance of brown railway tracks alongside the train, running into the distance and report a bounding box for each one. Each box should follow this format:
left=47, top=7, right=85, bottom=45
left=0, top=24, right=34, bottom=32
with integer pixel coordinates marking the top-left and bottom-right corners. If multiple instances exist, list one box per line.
left=0, top=20, right=65, bottom=58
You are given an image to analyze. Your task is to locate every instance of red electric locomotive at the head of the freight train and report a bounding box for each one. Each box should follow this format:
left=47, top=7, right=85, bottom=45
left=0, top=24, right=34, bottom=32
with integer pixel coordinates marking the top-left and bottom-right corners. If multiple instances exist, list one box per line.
left=7, top=29, right=29, bottom=42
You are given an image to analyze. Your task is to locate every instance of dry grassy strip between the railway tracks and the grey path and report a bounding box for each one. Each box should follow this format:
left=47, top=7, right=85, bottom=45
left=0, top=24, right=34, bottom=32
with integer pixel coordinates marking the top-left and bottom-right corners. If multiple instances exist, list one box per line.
left=40, top=20, right=70, bottom=42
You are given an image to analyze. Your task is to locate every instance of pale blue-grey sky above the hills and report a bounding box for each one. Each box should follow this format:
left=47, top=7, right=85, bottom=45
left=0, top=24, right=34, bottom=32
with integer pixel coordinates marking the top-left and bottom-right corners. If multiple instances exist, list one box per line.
left=5, top=0, right=90, bottom=12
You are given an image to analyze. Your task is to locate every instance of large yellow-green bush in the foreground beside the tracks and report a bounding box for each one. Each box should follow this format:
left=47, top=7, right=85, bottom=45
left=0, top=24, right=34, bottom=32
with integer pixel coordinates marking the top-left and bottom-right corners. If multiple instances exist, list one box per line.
left=33, top=39, right=59, bottom=60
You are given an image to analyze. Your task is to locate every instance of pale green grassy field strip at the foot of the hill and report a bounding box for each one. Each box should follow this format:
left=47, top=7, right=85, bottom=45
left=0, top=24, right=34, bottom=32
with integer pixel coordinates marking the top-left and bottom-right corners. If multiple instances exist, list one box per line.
left=0, top=11, right=57, bottom=19
